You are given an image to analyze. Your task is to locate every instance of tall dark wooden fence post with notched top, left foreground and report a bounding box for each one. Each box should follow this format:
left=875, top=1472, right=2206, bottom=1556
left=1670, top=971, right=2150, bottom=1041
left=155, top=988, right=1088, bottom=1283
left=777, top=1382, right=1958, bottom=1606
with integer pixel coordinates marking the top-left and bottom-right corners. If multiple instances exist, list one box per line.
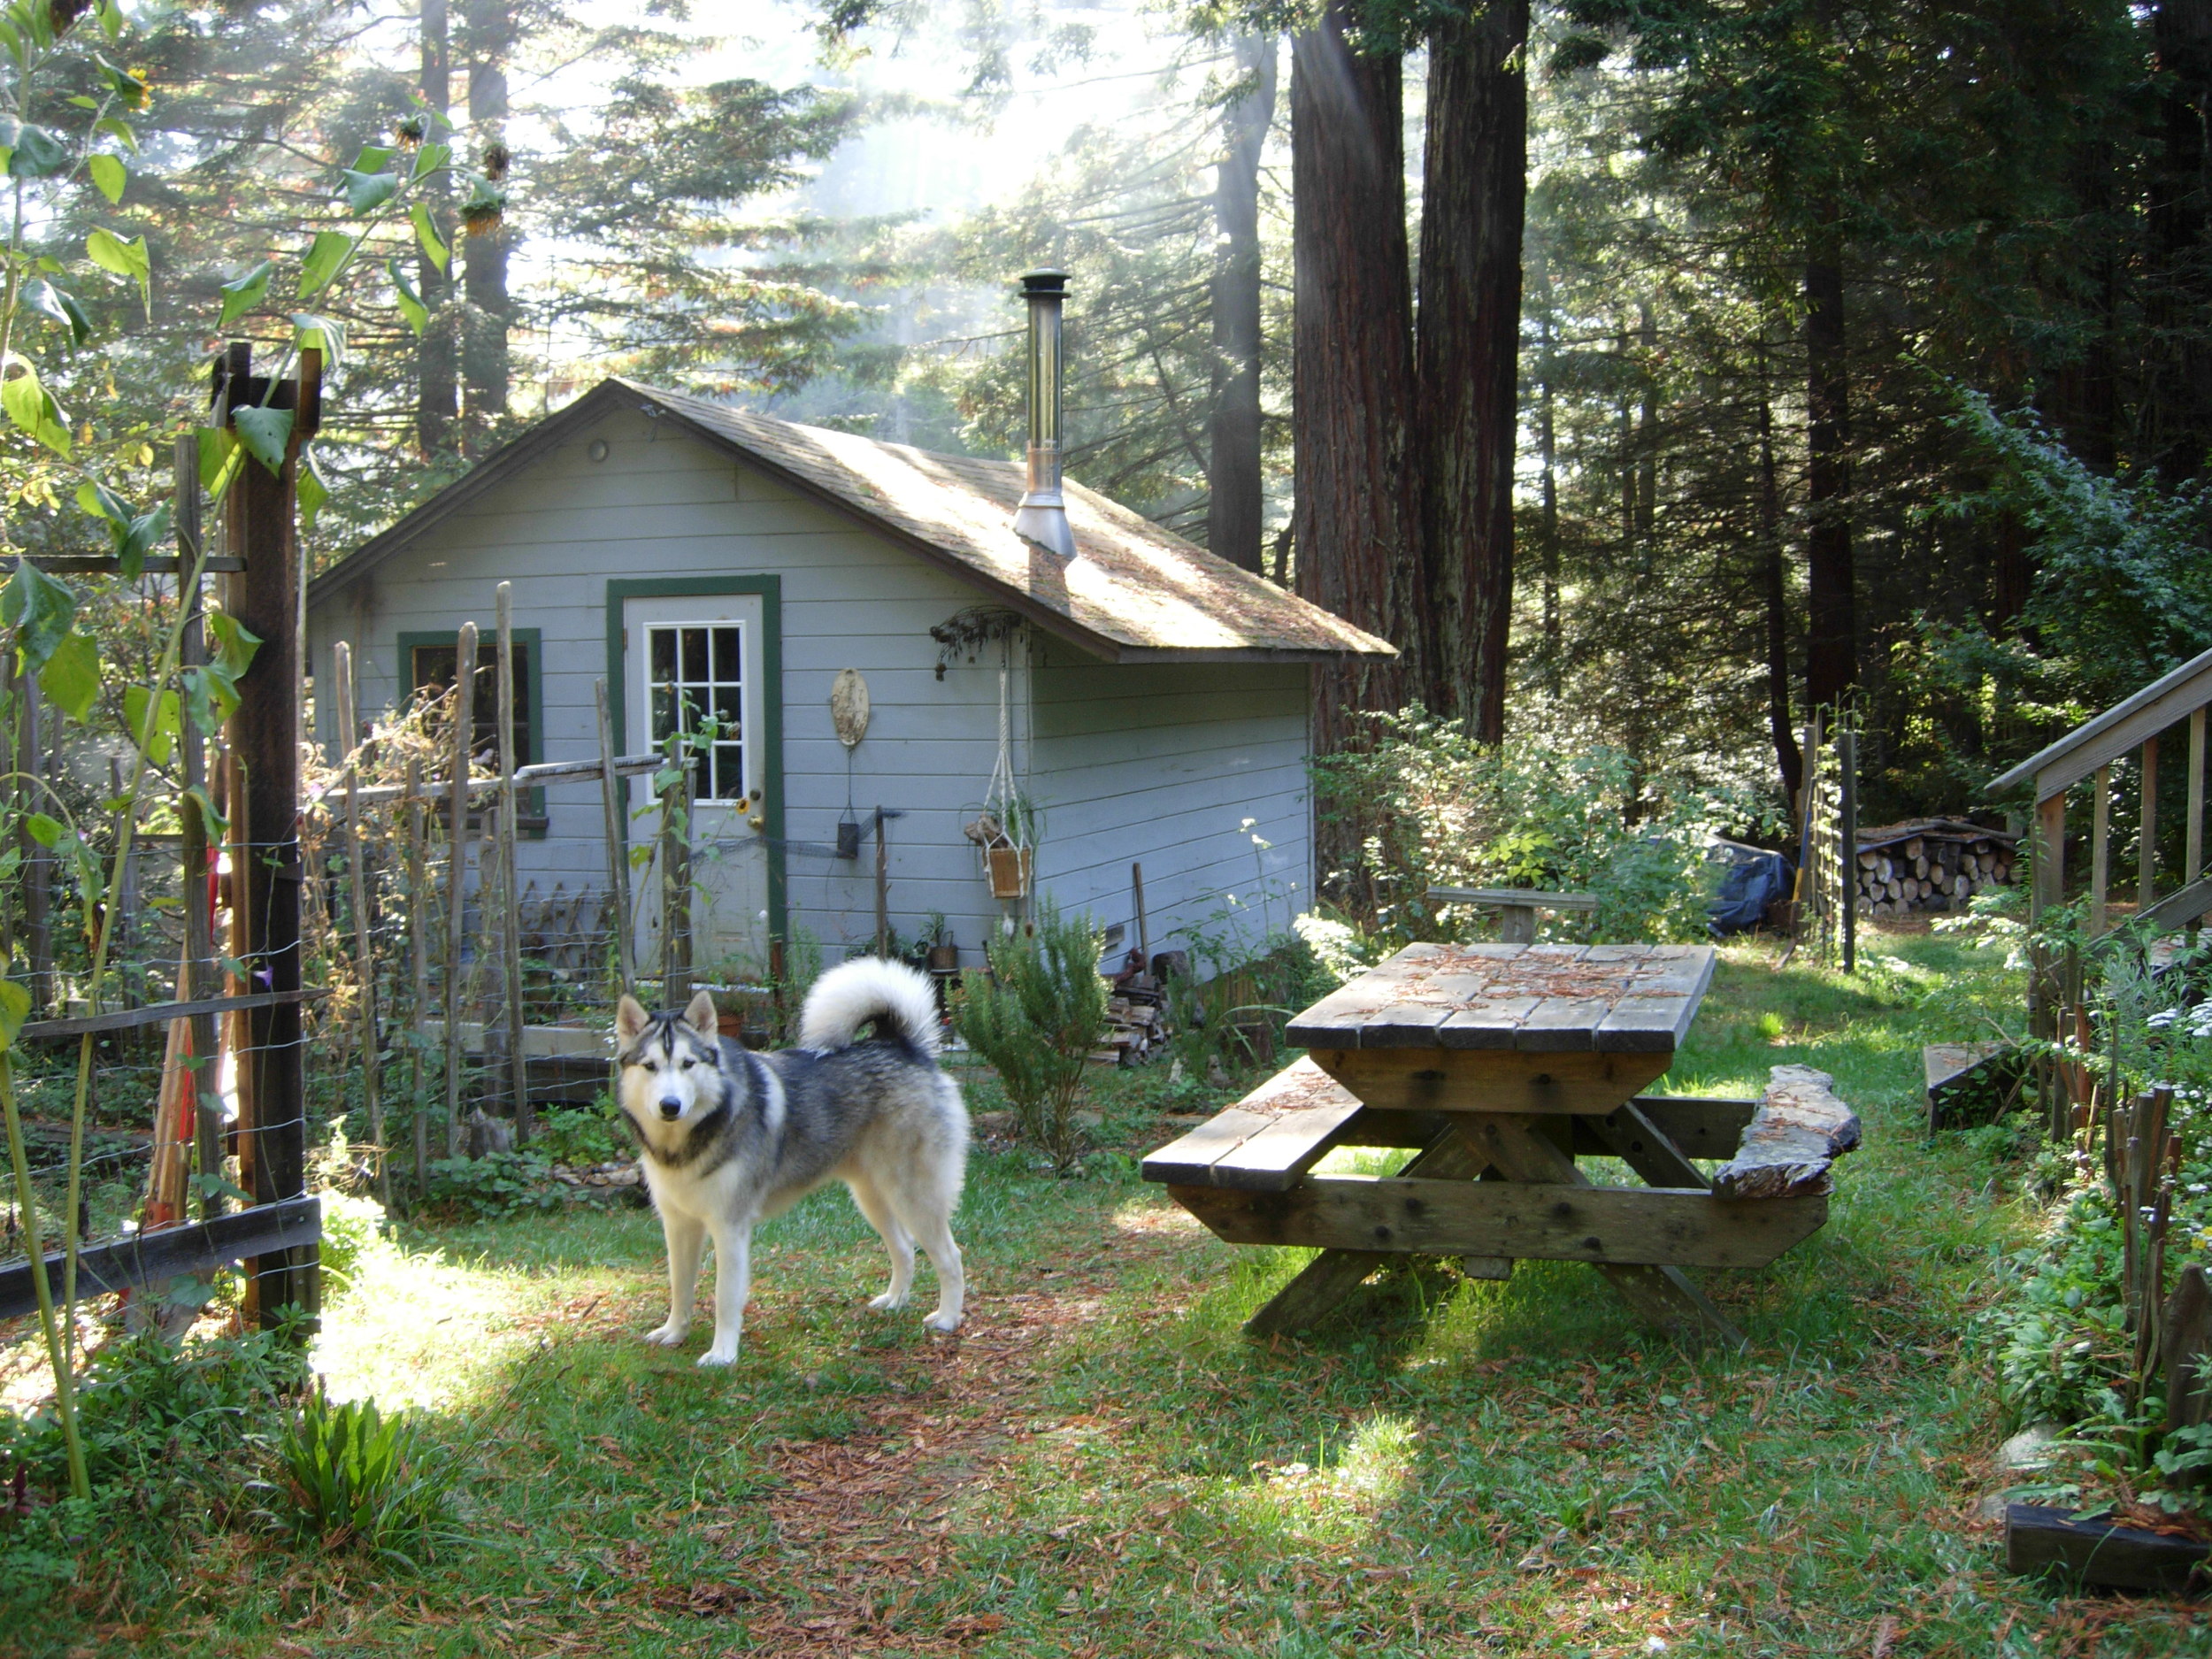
left=217, top=341, right=323, bottom=1325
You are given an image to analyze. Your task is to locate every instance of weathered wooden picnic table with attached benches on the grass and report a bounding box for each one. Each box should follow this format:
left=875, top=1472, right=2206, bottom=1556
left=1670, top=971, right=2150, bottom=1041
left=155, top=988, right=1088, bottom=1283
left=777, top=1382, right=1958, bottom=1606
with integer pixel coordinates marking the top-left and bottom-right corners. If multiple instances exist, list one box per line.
left=1144, top=945, right=1858, bottom=1343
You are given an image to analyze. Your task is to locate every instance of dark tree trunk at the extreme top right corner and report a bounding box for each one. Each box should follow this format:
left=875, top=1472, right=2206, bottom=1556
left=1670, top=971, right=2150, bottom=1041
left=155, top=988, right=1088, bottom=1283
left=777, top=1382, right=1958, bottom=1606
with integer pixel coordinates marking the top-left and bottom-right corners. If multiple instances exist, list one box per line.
left=2144, top=0, right=2212, bottom=480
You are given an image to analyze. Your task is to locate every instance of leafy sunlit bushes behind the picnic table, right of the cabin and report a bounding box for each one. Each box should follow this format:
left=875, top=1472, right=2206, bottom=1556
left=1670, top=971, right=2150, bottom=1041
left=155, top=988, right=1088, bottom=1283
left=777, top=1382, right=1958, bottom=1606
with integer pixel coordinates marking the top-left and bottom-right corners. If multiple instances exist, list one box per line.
left=1314, top=708, right=1746, bottom=949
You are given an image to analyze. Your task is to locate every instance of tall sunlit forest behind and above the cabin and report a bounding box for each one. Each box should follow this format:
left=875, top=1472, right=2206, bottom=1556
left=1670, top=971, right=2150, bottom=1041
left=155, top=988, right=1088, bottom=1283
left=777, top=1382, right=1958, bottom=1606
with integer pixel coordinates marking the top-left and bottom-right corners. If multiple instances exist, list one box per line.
left=26, top=0, right=2212, bottom=836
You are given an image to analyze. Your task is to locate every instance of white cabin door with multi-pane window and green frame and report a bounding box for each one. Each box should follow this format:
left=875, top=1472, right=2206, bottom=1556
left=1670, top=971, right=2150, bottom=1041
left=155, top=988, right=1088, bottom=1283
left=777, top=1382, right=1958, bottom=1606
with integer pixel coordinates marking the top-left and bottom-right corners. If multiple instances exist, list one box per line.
left=622, top=593, right=768, bottom=982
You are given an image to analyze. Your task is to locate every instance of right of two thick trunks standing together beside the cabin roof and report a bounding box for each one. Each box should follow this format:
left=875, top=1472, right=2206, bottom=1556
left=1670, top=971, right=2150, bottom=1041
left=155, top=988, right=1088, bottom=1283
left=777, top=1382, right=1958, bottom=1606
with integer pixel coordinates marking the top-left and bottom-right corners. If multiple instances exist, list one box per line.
left=1409, top=0, right=1529, bottom=743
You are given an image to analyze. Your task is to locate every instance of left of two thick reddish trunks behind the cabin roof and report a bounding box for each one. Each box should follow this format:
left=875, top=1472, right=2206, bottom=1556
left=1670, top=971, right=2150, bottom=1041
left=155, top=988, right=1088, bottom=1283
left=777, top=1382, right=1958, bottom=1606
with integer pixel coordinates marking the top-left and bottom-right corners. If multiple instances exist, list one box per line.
left=1290, top=0, right=1427, bottom=765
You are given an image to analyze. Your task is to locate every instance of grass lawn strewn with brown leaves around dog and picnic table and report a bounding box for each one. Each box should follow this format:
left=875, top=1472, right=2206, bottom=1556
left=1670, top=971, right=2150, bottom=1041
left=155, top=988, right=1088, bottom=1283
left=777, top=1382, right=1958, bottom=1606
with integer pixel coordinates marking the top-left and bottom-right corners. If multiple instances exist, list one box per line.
left=17, top=933, right=2212, bottom=1659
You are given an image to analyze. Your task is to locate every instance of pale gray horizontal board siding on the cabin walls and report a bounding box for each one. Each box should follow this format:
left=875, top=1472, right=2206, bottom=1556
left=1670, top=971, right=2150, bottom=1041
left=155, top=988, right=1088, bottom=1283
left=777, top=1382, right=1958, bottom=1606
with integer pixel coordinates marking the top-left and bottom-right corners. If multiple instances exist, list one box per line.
left=308, top=416, right=1312, bottom=982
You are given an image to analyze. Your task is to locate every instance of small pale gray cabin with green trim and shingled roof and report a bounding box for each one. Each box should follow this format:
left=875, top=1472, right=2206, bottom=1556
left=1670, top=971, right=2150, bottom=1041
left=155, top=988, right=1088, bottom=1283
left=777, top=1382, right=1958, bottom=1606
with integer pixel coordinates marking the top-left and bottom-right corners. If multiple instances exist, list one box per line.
left=308, top=379, right=1392, bottom=978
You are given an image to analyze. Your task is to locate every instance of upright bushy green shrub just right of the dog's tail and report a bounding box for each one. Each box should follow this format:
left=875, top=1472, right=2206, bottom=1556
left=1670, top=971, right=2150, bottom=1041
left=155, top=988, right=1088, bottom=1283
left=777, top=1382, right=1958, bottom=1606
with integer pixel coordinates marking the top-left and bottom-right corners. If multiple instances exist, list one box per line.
left=954, top=901, right=1106, bottom=1171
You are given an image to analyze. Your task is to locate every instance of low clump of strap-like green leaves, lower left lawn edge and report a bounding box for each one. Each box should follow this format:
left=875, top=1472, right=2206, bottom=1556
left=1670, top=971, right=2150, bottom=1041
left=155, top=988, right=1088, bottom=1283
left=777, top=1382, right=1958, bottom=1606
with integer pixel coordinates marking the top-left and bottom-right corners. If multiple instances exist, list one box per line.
left=277, top=1385, right=451, bottom=1569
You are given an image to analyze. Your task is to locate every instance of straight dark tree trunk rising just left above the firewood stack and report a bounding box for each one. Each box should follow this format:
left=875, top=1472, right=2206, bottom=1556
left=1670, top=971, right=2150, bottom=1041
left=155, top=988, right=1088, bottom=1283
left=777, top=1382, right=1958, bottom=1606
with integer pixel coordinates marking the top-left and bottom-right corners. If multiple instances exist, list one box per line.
left=1805, top=219, right=1858, bottom=708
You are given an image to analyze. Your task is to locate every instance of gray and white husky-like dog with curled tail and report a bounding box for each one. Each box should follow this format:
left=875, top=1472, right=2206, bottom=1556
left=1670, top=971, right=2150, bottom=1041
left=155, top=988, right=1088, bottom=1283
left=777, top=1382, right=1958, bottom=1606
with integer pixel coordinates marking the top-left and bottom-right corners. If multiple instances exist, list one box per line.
left=615, top=958, right=967, bottom=1365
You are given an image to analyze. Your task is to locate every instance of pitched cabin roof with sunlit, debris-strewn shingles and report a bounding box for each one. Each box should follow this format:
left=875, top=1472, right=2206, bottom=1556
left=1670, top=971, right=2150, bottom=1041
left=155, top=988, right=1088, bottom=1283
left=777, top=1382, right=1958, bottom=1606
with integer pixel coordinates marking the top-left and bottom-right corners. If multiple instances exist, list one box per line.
left=308, top=379, right=1396, bottom=662
